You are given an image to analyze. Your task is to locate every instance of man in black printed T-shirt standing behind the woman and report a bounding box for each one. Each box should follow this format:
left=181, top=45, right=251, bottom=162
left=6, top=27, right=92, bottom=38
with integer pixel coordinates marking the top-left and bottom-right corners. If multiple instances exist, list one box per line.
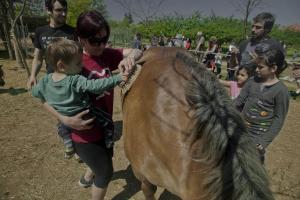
left=27, top=0, right=75, bottom=89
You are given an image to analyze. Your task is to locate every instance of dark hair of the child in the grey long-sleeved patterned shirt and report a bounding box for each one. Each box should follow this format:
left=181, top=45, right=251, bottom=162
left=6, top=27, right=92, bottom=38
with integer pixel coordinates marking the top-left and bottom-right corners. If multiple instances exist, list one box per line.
left=255, top=43, right=287, bottom=75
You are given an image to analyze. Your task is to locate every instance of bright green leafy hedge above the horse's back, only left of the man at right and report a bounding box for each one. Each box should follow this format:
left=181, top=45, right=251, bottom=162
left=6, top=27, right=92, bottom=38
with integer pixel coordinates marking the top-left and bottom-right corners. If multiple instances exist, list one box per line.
left=137, top=14, right=243, bottom=43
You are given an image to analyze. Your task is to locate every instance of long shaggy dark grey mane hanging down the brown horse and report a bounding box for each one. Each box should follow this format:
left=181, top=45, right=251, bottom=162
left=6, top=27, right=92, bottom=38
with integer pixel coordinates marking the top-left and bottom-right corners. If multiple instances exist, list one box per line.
left=177, top=53, right=273, bottom=200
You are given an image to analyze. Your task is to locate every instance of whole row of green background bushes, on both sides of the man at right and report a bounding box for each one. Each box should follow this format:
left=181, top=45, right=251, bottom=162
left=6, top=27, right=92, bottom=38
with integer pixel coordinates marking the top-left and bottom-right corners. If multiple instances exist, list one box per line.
left=112, top=12, right=300, bottom=48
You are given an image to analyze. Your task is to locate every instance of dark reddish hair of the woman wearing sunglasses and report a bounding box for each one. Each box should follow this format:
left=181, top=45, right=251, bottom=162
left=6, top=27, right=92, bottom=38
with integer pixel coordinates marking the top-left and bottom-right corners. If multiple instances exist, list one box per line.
left=76, top=10, right=110, bottom=38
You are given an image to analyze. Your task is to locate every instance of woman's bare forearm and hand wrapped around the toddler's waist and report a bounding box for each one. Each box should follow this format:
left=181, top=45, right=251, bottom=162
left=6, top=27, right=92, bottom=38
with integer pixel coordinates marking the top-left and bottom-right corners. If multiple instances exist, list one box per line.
left=43, top=102, right=95, bottom=130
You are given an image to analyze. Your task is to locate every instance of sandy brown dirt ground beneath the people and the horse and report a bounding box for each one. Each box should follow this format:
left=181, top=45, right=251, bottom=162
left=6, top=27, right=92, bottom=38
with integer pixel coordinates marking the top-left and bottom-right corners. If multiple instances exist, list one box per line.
left=0, top=59, right=300, bottom=200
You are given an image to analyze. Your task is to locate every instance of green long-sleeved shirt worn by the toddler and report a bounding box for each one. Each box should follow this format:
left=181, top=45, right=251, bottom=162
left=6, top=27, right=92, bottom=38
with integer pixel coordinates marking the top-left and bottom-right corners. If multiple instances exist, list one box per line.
left=31, top=73, right=122, bottom=116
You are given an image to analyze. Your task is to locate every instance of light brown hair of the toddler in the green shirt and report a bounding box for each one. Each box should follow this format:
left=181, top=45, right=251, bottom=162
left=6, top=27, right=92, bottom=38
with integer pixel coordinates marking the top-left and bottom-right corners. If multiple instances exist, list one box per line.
left=46, top=38, right=82, bottom=70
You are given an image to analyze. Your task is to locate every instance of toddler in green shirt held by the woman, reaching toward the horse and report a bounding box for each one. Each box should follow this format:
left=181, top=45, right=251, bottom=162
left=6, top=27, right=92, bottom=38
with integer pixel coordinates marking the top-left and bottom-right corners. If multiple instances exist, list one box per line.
left=32, top=38, right=128, bottom=155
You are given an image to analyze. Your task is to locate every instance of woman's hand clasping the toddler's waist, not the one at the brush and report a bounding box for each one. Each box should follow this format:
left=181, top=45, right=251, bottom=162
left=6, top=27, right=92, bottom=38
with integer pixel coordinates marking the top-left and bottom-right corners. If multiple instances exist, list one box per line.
left=60, top=110, right=95, bottom=131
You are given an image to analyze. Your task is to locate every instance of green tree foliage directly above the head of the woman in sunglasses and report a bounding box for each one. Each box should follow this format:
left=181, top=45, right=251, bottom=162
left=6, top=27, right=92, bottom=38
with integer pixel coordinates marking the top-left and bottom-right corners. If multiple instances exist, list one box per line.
left=67, top=0, right=107, bottom=26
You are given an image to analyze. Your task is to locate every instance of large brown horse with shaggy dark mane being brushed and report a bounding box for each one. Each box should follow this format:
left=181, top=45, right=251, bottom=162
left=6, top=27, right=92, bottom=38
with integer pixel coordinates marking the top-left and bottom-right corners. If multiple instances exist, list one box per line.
left=122, top=47, right=273, bottom=200
